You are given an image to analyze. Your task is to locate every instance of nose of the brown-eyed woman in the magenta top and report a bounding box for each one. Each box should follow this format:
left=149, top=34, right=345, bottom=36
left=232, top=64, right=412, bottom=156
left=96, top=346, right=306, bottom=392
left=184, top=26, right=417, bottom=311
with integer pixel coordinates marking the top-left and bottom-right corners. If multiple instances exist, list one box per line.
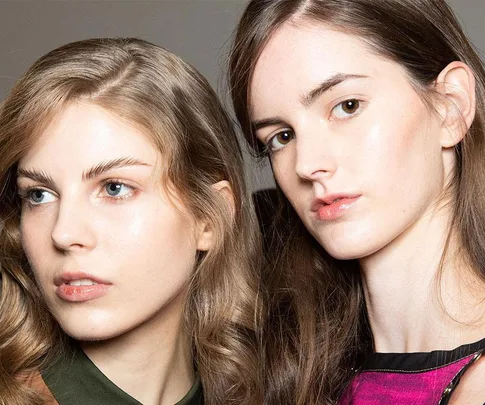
left=295, top=125, right=337, bottom=181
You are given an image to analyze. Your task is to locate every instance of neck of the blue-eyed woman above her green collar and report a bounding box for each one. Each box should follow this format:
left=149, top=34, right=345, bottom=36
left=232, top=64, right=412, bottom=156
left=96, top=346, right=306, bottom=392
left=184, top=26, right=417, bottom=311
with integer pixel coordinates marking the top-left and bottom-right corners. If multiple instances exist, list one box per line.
left=81, top=292, right=194, bottom=405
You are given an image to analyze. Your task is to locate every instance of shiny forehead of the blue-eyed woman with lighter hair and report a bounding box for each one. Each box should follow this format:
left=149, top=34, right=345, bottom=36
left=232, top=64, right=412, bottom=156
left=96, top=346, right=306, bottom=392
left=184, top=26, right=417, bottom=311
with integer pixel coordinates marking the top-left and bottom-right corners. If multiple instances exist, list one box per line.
left=19, top=102, right=157, bottom=170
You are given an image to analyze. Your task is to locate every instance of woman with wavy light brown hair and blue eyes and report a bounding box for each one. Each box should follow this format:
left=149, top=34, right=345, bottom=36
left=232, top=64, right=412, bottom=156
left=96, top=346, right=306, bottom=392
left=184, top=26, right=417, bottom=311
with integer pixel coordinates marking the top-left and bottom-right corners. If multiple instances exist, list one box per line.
left=0, top=38, right=262, bottom=405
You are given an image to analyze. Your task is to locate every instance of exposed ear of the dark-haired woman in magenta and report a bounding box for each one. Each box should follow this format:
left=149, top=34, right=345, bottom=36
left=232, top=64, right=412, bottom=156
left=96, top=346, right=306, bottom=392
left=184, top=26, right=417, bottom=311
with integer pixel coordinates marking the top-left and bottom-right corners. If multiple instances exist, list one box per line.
left=435, top=61, right=476, bottom=148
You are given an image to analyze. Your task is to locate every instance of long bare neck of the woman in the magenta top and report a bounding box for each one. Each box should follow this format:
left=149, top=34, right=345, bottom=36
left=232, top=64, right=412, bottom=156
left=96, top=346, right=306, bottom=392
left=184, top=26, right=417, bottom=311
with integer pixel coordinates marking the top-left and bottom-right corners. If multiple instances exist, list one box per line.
left=360, top=207, right=485, bottom=352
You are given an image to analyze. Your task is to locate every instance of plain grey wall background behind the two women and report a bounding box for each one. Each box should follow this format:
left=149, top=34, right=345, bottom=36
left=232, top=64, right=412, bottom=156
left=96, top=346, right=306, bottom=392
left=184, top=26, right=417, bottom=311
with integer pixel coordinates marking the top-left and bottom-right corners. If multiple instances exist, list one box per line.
left=0, top=0, right=485, bottom=189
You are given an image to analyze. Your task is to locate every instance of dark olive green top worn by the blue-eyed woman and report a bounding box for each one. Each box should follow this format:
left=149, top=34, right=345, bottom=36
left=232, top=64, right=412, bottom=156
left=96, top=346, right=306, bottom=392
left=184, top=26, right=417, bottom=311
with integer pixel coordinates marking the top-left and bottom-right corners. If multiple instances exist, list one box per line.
left=41, top=346, right=204, bottom=405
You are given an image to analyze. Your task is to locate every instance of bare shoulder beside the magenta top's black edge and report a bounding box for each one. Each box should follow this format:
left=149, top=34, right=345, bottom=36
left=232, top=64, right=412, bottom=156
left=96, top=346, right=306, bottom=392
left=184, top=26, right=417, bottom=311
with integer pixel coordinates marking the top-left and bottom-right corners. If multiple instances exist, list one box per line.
left=449, top=353, right=485, bottom=405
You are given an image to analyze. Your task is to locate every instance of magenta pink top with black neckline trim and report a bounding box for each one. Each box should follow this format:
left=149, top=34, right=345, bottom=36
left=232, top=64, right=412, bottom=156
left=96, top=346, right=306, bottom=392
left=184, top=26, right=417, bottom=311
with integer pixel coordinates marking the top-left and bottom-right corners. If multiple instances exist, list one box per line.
left=339, top=339, right=485, bottom=405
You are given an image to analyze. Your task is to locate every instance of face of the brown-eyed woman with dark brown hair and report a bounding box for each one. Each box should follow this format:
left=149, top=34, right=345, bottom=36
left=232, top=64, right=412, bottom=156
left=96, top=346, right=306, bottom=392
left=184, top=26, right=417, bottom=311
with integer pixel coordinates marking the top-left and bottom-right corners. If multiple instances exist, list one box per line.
left=250, top=23, right=447, bottom=259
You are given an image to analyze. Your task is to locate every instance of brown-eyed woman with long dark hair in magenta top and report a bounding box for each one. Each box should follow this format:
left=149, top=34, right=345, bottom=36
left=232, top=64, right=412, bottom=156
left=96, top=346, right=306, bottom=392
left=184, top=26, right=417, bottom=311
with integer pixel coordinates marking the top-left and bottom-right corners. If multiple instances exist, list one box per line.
left=230, top=0, right=485, bottom=405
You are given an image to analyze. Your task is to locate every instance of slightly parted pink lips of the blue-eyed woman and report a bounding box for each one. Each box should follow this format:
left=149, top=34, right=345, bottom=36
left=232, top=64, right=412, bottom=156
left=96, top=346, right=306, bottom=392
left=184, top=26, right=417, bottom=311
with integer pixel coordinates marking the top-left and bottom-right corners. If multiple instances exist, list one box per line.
left=54, top=272, right=112, bottom=302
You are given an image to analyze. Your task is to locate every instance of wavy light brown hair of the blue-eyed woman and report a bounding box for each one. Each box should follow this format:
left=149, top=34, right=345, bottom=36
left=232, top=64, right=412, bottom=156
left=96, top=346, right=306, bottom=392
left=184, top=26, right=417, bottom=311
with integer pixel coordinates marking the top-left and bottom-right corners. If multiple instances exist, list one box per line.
left=0, top=38, right=262, bottom=405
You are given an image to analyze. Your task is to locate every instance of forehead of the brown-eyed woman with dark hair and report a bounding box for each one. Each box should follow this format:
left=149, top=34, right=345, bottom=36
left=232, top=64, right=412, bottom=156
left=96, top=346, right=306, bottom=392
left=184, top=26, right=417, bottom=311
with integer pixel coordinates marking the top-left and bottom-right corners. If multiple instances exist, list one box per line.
left=250, top=22, right=399, bottom=115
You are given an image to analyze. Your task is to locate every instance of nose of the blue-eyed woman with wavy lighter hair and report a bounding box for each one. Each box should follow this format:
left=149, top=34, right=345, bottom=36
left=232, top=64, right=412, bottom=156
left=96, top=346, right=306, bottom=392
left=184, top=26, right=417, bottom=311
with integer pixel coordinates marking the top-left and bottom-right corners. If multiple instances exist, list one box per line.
left=51, top=197, right=96, bottom=252
